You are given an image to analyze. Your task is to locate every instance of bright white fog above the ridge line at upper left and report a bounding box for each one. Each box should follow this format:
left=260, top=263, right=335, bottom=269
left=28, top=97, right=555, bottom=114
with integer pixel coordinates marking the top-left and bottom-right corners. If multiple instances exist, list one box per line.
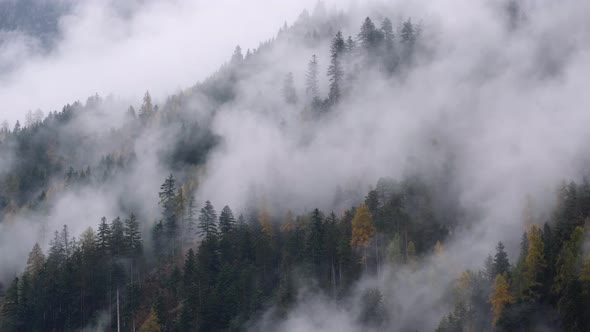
left=0, top=0, right=342, bottom=124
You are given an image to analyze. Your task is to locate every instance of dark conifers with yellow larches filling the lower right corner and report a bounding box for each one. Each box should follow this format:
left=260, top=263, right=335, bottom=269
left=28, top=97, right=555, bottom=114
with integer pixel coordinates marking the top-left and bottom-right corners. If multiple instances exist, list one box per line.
left=437, top=181, right=590, bottom=332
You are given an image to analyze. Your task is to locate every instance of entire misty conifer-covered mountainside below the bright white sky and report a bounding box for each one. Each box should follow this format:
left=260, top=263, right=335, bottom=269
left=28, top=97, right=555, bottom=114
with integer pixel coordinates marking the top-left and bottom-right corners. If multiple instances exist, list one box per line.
left=0, top=1, right=590, bottom=332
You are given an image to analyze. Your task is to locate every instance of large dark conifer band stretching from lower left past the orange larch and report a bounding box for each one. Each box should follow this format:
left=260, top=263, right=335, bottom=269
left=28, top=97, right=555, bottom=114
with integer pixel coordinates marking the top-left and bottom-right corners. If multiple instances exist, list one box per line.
left=0, top=169, right=446, bottom=331
